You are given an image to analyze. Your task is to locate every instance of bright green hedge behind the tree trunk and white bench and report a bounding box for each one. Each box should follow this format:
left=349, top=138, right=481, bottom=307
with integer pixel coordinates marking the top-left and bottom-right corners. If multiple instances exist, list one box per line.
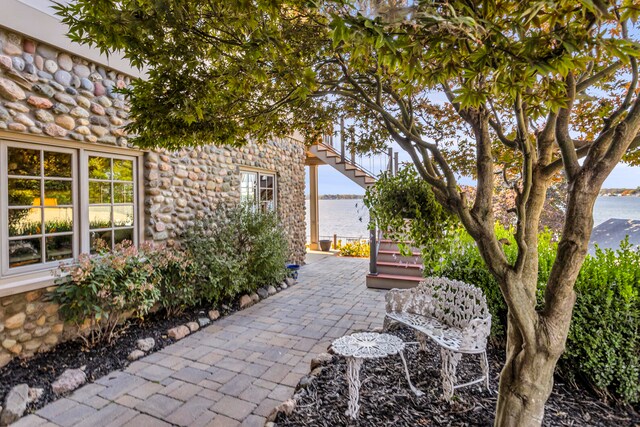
left=425, top=226, right=640, bottom=402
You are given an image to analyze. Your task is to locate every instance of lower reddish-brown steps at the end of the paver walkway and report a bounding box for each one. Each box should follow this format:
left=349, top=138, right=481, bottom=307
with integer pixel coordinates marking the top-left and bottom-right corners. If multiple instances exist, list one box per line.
left=367, top=239, right=423, bottom=289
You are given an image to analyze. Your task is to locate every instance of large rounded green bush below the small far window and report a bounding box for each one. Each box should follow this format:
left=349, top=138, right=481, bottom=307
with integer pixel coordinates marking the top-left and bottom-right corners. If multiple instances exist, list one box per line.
left=182, top=207, right=288, bottom=303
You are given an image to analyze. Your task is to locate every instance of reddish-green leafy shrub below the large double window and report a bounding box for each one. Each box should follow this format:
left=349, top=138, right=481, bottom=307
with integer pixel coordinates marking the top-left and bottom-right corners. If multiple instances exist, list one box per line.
left=51, top=241, right=160, bottom=346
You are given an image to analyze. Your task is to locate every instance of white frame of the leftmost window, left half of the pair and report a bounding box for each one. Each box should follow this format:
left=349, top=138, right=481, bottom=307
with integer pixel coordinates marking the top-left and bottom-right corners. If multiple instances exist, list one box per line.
left=0, top=140, right=80, bottom=276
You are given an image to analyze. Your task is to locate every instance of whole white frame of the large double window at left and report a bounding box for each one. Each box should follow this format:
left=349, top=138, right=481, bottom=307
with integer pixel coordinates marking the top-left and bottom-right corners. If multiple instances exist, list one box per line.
left=0, top=139, right=144, bottom=282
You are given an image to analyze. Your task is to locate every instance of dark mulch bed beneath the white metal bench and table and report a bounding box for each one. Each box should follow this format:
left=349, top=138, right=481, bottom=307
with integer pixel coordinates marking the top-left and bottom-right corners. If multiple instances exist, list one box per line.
left=276, top=328, right=640, bottom=427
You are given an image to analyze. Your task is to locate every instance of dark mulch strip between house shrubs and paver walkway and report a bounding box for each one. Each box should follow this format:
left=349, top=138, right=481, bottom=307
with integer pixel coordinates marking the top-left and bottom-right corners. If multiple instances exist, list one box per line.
left=0, top=306, right=237, bottom=413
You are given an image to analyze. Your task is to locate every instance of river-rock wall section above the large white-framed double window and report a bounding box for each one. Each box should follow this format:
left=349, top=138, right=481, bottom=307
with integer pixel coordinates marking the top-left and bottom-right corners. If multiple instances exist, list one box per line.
left=0, top=29, right=130, bottom=146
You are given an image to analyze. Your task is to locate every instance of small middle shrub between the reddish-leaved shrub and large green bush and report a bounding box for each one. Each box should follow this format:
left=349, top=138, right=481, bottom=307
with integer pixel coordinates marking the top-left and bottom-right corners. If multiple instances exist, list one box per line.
left=149, top=247, right=199, bottom=317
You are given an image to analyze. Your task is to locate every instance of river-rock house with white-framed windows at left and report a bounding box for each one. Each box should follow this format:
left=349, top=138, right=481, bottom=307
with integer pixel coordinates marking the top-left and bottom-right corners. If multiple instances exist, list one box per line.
left=0, top=0, right=306, bottom=367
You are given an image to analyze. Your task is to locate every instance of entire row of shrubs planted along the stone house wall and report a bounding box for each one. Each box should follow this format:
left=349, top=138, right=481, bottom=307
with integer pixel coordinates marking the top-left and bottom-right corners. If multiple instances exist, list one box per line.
left=50, top=206, right=289, bottom=347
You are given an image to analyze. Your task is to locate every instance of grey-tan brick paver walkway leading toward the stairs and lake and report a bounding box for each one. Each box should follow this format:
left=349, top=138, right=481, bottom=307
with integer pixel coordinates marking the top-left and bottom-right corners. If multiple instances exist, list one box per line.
left=15, top=257, right=384, bottom=427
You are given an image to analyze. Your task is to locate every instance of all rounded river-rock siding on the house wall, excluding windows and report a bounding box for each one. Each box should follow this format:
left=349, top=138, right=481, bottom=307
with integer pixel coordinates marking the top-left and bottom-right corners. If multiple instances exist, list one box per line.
left=0, top=28, right=306, bottom=367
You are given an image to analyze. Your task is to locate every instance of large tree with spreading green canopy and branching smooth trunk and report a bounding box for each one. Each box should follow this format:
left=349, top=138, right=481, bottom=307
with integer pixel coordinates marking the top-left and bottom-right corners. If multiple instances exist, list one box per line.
left=59, top=0, right=640, bottom=425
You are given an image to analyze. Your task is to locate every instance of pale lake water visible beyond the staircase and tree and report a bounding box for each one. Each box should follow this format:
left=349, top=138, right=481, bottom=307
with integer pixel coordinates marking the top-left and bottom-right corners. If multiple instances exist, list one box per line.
left=306, top=196, right=640, bottom=240
